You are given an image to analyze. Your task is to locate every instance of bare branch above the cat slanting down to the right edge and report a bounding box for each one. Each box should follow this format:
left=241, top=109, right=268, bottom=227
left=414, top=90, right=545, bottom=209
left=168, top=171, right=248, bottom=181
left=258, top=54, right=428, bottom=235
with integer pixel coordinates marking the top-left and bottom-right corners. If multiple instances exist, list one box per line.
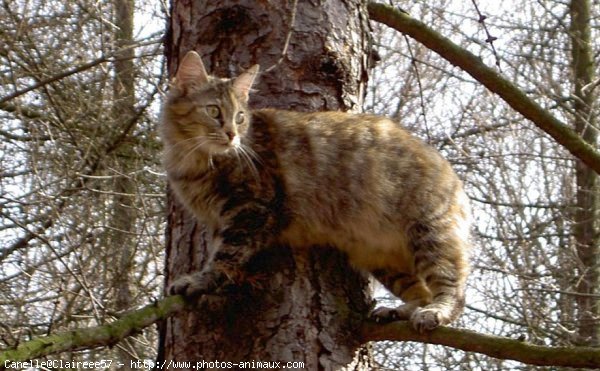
left=368, top=2, right=600, bottom=174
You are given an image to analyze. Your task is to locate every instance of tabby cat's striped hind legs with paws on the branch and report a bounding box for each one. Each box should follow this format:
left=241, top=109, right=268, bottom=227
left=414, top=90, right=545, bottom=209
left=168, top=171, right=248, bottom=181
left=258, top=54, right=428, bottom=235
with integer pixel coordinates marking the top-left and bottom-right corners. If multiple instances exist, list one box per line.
left=371, top=223, right=469, bottom=332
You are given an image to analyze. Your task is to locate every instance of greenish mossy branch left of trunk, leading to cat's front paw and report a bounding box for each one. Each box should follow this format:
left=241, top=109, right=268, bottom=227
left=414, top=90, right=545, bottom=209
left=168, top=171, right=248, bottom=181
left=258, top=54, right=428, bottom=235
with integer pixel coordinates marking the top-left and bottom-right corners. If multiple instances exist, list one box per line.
left=0, top=296, right=185, bottom=367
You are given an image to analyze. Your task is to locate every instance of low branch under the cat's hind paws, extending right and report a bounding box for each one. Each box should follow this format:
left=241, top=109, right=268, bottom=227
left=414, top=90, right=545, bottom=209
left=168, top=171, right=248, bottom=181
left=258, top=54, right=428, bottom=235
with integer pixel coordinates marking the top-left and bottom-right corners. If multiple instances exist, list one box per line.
left=361, top=321, right=600, bottom=368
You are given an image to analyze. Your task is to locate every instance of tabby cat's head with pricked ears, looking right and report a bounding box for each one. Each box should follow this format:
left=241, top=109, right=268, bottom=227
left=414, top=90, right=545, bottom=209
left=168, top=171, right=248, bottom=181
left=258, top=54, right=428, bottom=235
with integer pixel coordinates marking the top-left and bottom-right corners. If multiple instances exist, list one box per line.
left=162, top=51, right=258, bottom=156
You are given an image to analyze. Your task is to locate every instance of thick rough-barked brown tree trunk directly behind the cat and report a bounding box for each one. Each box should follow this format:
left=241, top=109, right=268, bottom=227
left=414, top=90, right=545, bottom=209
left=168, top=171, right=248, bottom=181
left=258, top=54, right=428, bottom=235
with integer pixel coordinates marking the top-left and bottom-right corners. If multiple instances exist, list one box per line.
left=160, top=0, right=370, bottom=370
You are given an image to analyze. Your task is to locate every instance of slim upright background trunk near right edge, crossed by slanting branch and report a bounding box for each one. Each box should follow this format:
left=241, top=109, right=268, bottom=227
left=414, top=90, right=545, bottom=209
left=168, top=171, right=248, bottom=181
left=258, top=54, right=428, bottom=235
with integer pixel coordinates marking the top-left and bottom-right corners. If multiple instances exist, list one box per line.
left=570, top=0, right=600, bottom=345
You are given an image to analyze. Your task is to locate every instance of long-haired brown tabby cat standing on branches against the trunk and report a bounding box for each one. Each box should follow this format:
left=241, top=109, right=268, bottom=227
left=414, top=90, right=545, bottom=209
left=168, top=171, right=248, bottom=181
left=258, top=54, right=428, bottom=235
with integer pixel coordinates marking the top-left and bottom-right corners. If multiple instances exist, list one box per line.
left=161, top=51, right=470, bottom=332
